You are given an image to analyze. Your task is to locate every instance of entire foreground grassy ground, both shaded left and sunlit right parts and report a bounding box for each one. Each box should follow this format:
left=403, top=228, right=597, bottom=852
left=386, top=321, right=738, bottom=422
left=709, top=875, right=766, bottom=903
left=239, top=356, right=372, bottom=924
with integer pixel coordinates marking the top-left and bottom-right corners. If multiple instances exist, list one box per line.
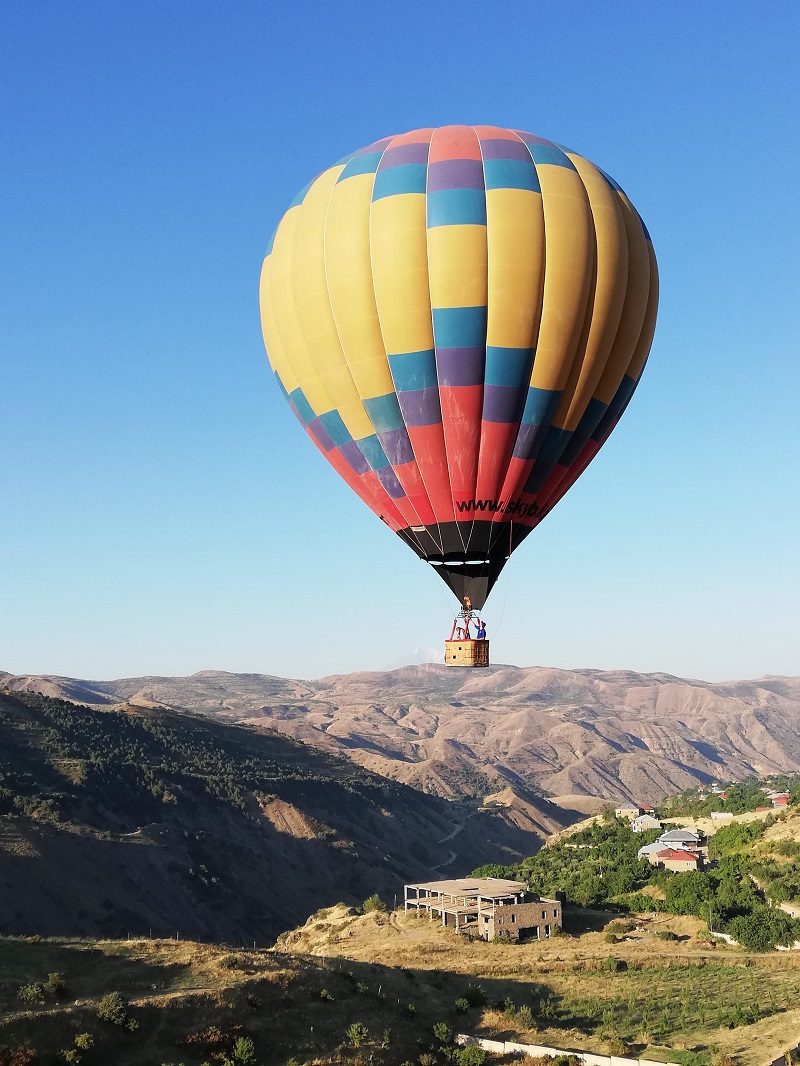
left=6, top=906, right=800, bottom=1066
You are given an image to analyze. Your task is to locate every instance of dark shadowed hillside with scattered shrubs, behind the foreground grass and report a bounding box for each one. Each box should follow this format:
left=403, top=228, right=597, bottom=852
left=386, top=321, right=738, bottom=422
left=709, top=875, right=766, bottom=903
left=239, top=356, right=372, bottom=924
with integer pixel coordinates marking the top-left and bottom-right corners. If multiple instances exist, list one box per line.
left=0, top=691, right=566, bottom=944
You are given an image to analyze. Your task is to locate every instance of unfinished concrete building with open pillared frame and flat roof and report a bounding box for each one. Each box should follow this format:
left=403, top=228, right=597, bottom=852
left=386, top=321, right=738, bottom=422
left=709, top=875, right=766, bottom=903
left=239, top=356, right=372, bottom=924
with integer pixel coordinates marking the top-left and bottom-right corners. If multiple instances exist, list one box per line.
left=404, top=877, right=563, bottom=940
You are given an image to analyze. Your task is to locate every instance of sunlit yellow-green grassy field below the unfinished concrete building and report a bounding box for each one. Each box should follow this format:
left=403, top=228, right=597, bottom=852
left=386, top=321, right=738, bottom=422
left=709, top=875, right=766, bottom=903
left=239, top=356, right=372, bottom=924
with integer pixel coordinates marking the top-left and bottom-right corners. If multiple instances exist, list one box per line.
left=287, top=912, right=800, bottom=1066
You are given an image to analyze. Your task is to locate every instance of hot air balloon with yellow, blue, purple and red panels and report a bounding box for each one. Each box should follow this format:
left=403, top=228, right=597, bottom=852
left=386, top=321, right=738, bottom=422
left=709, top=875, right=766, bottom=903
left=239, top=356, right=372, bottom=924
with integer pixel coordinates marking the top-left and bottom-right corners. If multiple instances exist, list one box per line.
left=260, top=126, right=658, bottom=661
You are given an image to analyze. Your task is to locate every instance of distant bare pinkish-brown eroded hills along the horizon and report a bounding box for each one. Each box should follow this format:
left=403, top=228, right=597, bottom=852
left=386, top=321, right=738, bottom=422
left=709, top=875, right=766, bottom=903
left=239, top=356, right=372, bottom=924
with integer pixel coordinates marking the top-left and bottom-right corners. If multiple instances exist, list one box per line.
left=4, top=664, right=800, bottom=801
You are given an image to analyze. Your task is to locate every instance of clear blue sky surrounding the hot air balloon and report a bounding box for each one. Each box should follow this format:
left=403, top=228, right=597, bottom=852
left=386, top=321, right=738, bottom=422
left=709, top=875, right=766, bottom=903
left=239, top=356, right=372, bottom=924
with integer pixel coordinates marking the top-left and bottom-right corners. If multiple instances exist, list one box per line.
left=0, top=0, right=800, bottom=679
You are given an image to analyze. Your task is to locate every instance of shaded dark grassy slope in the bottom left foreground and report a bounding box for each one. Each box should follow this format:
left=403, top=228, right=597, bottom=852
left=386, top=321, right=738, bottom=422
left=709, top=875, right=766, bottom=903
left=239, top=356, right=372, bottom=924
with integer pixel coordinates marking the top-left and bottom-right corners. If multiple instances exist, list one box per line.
left=0, top=925, right=494, bottom=1066
